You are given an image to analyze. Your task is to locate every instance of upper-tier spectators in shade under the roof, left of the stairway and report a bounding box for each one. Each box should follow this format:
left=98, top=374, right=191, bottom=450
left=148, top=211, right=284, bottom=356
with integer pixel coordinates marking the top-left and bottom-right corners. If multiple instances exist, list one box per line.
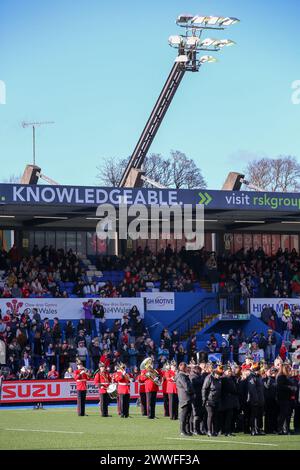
left=0, top=245, right=197, bottom=298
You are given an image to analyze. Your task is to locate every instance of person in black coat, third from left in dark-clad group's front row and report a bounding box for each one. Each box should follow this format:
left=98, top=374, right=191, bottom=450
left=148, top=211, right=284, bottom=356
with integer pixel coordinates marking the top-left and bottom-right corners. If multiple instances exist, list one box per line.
left=202, top=365, right=223, bottom=437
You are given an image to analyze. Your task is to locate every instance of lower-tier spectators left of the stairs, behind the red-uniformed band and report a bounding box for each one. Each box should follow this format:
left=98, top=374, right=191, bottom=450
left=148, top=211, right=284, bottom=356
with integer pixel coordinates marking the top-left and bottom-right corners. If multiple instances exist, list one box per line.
left=0, top=300, right=162, bottom=379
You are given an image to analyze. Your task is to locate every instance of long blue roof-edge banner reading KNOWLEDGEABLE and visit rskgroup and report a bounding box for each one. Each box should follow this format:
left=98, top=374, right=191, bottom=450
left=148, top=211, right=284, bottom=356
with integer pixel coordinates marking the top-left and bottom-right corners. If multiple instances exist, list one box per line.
left=0, top=184, right=300, bottom=212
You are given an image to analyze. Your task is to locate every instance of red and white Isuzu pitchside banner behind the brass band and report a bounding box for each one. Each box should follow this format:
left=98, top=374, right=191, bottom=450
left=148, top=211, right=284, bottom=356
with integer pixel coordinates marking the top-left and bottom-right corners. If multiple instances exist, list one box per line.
left=0, top=379, right=162, bottom=404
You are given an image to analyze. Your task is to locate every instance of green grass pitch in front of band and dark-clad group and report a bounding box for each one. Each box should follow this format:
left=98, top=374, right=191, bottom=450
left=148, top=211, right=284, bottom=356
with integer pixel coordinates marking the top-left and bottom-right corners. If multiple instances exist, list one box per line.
left=0, top=404, right=300, bottom=451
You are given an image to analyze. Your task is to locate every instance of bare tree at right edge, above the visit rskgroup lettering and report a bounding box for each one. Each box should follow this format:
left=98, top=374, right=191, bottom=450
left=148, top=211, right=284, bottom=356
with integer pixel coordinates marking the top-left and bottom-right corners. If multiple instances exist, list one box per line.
left=245, top=156, right=300, bottom=192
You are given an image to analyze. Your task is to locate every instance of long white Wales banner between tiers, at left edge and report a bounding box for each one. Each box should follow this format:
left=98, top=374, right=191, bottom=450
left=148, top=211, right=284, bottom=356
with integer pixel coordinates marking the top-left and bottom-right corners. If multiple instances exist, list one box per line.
left=0, top=297, right=144, bottom=320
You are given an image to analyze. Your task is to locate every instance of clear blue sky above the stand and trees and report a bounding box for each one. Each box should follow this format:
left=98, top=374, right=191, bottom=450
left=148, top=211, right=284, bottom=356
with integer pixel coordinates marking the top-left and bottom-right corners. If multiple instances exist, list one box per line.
left=0, top=0, right=300, bottom=189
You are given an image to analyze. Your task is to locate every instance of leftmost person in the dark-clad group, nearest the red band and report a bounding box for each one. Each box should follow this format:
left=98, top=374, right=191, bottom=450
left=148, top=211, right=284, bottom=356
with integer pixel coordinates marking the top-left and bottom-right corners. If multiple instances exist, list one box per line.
left=175, top=362, right=193, bottom=436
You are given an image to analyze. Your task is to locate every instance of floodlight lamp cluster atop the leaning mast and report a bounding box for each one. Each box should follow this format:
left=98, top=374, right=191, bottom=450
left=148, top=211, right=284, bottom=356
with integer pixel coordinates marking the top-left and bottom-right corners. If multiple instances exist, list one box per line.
left=169, top=15, right=239, bottom=71
